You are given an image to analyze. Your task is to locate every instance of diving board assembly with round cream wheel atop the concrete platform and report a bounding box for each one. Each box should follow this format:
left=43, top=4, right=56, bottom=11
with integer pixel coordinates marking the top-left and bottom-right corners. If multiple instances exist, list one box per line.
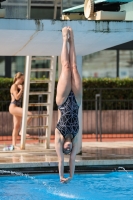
left=62, top=0, right=133, bottom=21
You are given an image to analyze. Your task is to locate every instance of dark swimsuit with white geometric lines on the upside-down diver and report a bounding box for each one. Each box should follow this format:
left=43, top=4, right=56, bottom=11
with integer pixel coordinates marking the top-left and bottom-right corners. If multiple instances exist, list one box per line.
left=56, top=90, right=79, bottom=138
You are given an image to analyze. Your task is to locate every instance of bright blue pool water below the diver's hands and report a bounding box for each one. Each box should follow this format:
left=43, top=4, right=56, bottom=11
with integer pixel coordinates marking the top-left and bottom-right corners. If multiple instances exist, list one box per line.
left=0, top=172, right=133, bottom=200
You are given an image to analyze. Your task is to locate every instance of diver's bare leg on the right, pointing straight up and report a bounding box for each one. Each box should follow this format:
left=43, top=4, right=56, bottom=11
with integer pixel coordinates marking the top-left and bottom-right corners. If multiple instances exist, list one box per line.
left=68, top=27, right=82, bottom=105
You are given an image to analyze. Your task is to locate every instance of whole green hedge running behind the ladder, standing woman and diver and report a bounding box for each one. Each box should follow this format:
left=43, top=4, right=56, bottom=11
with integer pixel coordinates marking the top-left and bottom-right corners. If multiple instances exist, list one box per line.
left=0, top=78, right=133, bottom=110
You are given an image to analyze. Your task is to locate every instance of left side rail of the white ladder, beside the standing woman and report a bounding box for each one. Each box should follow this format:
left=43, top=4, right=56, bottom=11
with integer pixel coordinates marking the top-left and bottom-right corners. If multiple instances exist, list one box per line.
left=21, top=56, right=31, bottom=149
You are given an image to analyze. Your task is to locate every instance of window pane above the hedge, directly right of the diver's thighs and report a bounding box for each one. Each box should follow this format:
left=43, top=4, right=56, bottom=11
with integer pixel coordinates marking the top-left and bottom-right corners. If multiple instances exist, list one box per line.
left=83, top=50, right=116, bottom=78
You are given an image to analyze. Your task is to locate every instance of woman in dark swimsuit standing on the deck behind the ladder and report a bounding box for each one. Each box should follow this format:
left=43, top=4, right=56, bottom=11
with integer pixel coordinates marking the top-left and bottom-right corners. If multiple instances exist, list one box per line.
left=9, top=72, right=32, bottom=149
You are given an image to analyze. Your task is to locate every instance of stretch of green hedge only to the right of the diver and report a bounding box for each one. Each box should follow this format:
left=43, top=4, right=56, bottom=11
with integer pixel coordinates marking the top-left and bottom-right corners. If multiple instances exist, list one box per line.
left=83, top=78, right=133, bottom=110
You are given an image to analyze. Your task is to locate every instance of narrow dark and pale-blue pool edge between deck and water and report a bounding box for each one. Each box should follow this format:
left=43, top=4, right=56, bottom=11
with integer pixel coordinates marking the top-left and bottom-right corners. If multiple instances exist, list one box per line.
left=0, top=159, right=133, bottom=175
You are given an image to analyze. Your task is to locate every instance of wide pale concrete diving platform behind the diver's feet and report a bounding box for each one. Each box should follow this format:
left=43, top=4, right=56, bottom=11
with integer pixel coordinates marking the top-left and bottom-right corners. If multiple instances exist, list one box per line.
left=0, top=19, right=133, bottom=56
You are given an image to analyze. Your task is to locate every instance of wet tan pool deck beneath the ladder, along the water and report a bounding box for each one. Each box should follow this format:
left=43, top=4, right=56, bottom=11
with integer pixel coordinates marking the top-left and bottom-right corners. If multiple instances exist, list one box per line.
left=0, top=141, right=133, bottom=170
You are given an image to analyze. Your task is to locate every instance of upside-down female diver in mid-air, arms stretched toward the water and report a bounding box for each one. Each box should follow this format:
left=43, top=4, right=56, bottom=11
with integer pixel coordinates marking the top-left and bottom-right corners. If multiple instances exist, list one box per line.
left=55, top=27, right=82, bottom=183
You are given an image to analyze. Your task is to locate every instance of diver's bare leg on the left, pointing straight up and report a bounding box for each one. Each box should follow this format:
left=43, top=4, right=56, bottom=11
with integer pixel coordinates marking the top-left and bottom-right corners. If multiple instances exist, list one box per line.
left=56, top=27, right=71, bottom=105
